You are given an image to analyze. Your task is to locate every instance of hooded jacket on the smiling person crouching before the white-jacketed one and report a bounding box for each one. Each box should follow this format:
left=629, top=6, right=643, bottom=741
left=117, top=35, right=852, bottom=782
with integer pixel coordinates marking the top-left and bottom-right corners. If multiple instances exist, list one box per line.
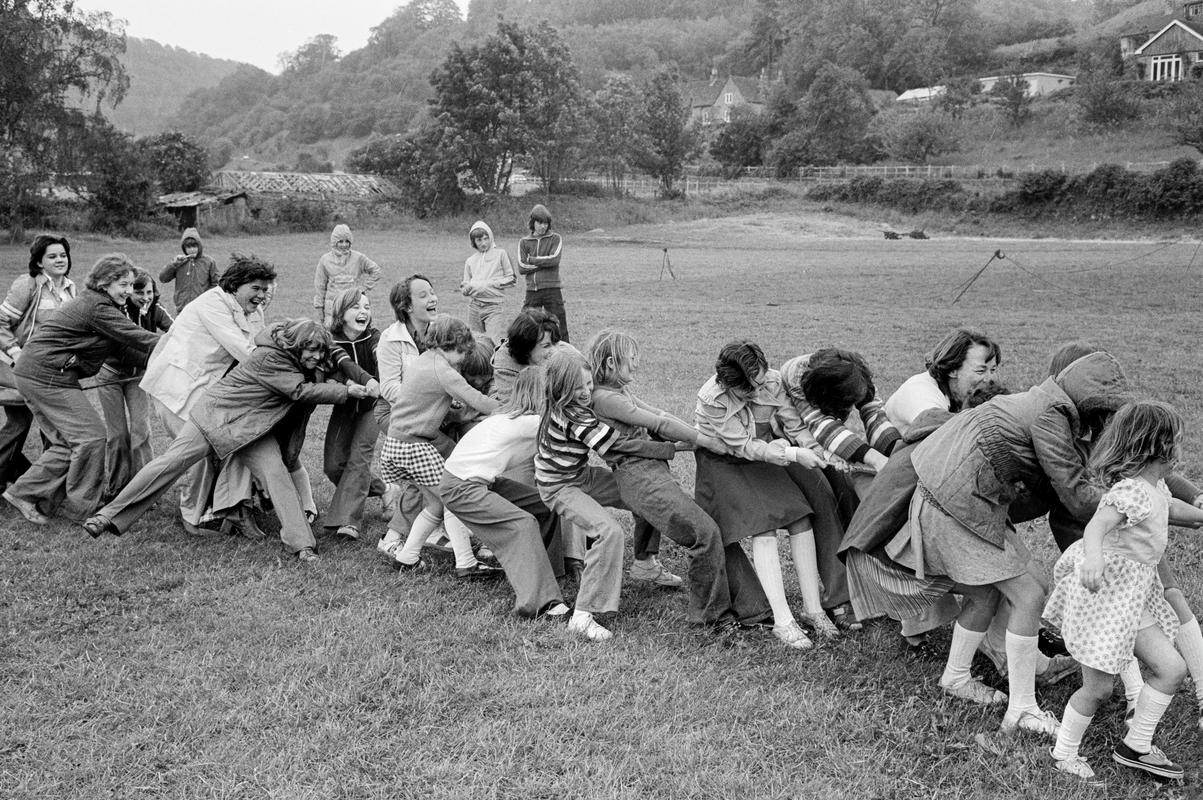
left=191, top=328, right=348, bottom=458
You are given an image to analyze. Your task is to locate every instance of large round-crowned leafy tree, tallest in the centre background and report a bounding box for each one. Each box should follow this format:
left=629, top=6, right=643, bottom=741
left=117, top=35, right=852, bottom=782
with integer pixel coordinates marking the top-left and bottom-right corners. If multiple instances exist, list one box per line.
left=431, top=20, right=583, bottom=194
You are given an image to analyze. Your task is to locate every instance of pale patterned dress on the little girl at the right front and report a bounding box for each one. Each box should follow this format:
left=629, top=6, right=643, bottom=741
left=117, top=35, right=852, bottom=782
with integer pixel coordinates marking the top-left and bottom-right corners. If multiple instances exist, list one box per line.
left=1044, top=478, right=1178, bottom=675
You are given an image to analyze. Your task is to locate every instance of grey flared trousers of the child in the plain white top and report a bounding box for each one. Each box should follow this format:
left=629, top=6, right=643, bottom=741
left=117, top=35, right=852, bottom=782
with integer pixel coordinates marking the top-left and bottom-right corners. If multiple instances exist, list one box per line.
left=439, top=470, right=564, bottom=617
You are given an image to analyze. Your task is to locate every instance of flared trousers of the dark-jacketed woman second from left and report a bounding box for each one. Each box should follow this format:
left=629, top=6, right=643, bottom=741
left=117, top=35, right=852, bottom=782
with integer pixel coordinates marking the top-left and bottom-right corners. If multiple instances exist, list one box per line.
left=8, top=375, right=106, bottom=522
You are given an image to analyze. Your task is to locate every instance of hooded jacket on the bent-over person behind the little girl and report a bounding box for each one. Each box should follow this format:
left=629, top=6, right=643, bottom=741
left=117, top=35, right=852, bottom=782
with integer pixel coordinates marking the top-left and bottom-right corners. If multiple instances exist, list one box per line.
left=912, top=352, right=1127, bottom=547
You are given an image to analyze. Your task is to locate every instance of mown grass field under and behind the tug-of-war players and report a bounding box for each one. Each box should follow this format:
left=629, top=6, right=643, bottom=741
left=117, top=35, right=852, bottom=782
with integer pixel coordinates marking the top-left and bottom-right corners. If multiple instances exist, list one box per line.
left=0, top=217, right=1203, bottom=799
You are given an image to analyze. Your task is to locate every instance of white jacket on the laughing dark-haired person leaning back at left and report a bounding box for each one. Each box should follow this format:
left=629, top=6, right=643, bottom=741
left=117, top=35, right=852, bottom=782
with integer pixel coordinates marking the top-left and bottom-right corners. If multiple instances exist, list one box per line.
left=138, top=286, right=265, bottom=411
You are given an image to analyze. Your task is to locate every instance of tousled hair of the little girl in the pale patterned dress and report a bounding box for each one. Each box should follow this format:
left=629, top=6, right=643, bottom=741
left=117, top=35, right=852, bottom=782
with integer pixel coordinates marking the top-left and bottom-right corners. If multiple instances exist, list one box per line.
left=1089, top=401, right=1183, bottom=486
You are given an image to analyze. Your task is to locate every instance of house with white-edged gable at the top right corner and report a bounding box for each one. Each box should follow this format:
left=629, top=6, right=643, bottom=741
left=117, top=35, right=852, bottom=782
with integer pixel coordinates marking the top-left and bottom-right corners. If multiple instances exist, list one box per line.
left=1120, top=0, right=1203, bottom=81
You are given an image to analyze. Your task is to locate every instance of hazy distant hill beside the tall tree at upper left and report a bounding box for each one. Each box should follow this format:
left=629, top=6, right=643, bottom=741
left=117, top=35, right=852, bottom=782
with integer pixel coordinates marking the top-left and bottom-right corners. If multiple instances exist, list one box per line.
left=101, top=36, right=247, bottom=136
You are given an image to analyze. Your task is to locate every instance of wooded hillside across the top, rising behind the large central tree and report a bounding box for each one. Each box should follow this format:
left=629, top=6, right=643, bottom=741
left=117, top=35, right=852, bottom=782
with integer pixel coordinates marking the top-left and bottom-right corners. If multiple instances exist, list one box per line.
left=159, top=0, right=1145, bottom=162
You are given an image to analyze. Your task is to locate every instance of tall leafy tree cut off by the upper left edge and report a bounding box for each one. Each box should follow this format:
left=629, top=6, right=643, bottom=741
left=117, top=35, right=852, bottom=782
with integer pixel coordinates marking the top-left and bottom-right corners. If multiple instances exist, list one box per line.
left=0, top=0, right=129, bottom=238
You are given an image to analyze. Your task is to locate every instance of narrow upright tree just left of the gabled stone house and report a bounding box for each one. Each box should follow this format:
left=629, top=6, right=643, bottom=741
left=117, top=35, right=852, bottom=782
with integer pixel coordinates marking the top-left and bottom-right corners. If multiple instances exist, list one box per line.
left=633, top=67, right=701, bottom=197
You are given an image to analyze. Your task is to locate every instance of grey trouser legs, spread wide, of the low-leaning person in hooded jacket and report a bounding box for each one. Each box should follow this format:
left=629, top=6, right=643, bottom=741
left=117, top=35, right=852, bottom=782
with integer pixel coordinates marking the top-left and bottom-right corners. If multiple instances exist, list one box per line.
left=96, top=422, right=316, bottom=553
